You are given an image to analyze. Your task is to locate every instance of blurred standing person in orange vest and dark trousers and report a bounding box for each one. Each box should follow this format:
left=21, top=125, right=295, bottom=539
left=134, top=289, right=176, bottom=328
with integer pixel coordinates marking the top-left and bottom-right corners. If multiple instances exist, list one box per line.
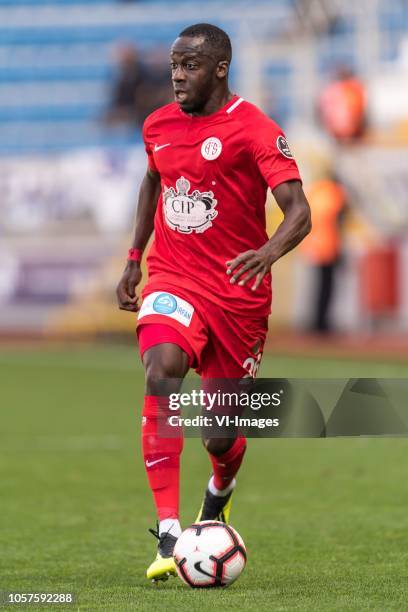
left=300, top=176, right=346, bottom=333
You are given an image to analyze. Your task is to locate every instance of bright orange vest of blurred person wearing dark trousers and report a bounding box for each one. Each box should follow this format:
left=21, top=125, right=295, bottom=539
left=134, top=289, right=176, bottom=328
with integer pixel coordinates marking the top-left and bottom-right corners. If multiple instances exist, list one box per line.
left=300, top=179, right=346, bottom=265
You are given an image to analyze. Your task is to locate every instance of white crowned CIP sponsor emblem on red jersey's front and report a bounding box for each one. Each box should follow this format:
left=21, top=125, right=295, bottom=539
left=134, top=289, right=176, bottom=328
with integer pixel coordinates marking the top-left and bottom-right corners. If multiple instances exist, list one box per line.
left=163, top=176, right=218, bottom=234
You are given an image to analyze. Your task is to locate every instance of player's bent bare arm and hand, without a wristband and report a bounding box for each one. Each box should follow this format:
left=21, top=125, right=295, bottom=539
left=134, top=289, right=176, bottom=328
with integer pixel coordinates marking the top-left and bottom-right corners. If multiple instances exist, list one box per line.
left=226, top=180, right=312, bottom=291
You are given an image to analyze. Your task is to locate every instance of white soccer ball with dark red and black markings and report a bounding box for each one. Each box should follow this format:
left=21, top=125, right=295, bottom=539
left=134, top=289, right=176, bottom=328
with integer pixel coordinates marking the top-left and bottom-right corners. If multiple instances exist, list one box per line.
left=174, top=521, right=246, bottom=588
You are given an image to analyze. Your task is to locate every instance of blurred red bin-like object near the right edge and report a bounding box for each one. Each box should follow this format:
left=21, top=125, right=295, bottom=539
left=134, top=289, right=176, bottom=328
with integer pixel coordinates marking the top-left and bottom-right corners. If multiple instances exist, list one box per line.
left=360, top=245, right=400, bottom=315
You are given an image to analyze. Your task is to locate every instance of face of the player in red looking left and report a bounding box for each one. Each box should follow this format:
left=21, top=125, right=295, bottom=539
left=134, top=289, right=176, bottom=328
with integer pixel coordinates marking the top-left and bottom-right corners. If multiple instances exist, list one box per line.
left=170, top=37, right=225, bottom=113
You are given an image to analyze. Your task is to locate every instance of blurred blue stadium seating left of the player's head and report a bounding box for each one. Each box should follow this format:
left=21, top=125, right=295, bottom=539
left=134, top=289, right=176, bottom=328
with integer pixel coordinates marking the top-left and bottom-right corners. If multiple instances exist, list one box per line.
left=0, top=0, right=182, bottom=154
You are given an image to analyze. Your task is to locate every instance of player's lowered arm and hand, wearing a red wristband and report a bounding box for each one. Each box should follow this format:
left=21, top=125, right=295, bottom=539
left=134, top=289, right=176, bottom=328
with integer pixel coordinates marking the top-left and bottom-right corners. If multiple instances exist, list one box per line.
left=116, top=168, right=161, bottom=312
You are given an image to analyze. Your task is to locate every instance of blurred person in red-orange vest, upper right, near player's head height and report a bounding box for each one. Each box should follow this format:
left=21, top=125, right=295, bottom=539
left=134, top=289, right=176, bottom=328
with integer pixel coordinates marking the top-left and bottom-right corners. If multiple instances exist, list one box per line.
left=318, top=67, right=366, bottom=142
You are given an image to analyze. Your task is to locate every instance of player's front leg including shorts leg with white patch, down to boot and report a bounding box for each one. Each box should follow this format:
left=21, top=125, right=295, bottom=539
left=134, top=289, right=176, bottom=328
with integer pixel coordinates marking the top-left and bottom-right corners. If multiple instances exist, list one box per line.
left=138, top=292, right=207, bottom=580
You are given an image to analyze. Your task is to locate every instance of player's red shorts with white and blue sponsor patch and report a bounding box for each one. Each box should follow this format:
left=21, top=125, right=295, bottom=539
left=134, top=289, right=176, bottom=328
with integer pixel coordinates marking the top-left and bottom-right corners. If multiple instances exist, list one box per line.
left=138, top=287, right=268, bottom=378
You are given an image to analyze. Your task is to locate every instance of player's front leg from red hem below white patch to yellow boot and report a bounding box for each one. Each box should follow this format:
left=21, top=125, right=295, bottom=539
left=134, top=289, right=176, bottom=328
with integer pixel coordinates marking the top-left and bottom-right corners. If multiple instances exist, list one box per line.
left=139, top=325, right=191, bottom=580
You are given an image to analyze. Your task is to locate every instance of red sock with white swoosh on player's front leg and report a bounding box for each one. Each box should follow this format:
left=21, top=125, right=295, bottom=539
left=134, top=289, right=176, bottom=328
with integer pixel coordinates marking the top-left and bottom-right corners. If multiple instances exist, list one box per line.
left=142, top=395, right=183, bottom=521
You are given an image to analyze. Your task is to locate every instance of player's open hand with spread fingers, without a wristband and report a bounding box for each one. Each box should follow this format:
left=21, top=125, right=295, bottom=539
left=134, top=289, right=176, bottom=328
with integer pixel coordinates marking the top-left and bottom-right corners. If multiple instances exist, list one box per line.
left=225, top=246, right=273, bottom=291
